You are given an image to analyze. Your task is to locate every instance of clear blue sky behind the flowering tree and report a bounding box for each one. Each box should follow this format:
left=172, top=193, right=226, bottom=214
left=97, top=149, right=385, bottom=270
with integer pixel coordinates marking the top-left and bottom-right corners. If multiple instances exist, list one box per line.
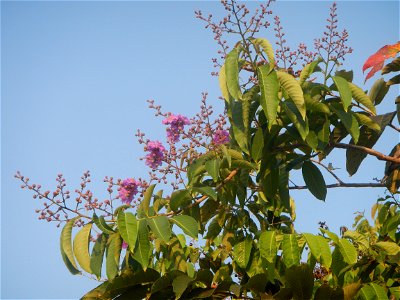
left=1, top=1, right=399, bottom=299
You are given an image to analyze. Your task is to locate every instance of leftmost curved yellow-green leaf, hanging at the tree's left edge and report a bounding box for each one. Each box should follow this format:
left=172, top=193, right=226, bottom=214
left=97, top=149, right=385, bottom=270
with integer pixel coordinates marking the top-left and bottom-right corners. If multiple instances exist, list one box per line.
left=60, top=217, right=80, bottom=275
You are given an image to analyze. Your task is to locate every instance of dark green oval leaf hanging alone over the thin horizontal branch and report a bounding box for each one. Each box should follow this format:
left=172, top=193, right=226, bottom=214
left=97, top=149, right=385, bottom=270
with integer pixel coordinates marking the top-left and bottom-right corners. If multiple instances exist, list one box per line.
left=301, top=161, right=327, bottom=201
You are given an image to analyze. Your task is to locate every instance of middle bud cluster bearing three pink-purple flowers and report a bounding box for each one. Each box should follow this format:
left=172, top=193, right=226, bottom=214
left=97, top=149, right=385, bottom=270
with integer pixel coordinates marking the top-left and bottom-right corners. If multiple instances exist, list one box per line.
left=135, top=93, right=230, bottom=189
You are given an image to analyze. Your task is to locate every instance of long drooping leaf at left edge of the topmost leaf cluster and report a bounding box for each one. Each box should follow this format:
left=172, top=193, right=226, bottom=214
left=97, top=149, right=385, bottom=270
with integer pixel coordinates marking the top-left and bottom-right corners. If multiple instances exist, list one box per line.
left=225, top=48, right=242, bottom=100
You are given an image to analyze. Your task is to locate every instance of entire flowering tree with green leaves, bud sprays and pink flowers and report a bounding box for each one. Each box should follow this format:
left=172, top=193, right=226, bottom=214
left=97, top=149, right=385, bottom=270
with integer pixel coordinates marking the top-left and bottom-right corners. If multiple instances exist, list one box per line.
left=17, top=2, right=400, bottom=299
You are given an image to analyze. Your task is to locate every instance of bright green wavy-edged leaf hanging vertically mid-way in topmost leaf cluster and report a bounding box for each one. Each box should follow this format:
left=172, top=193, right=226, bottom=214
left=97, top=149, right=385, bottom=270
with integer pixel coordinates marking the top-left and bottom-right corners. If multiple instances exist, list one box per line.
left=257, top=65, right=279, bottom=128
